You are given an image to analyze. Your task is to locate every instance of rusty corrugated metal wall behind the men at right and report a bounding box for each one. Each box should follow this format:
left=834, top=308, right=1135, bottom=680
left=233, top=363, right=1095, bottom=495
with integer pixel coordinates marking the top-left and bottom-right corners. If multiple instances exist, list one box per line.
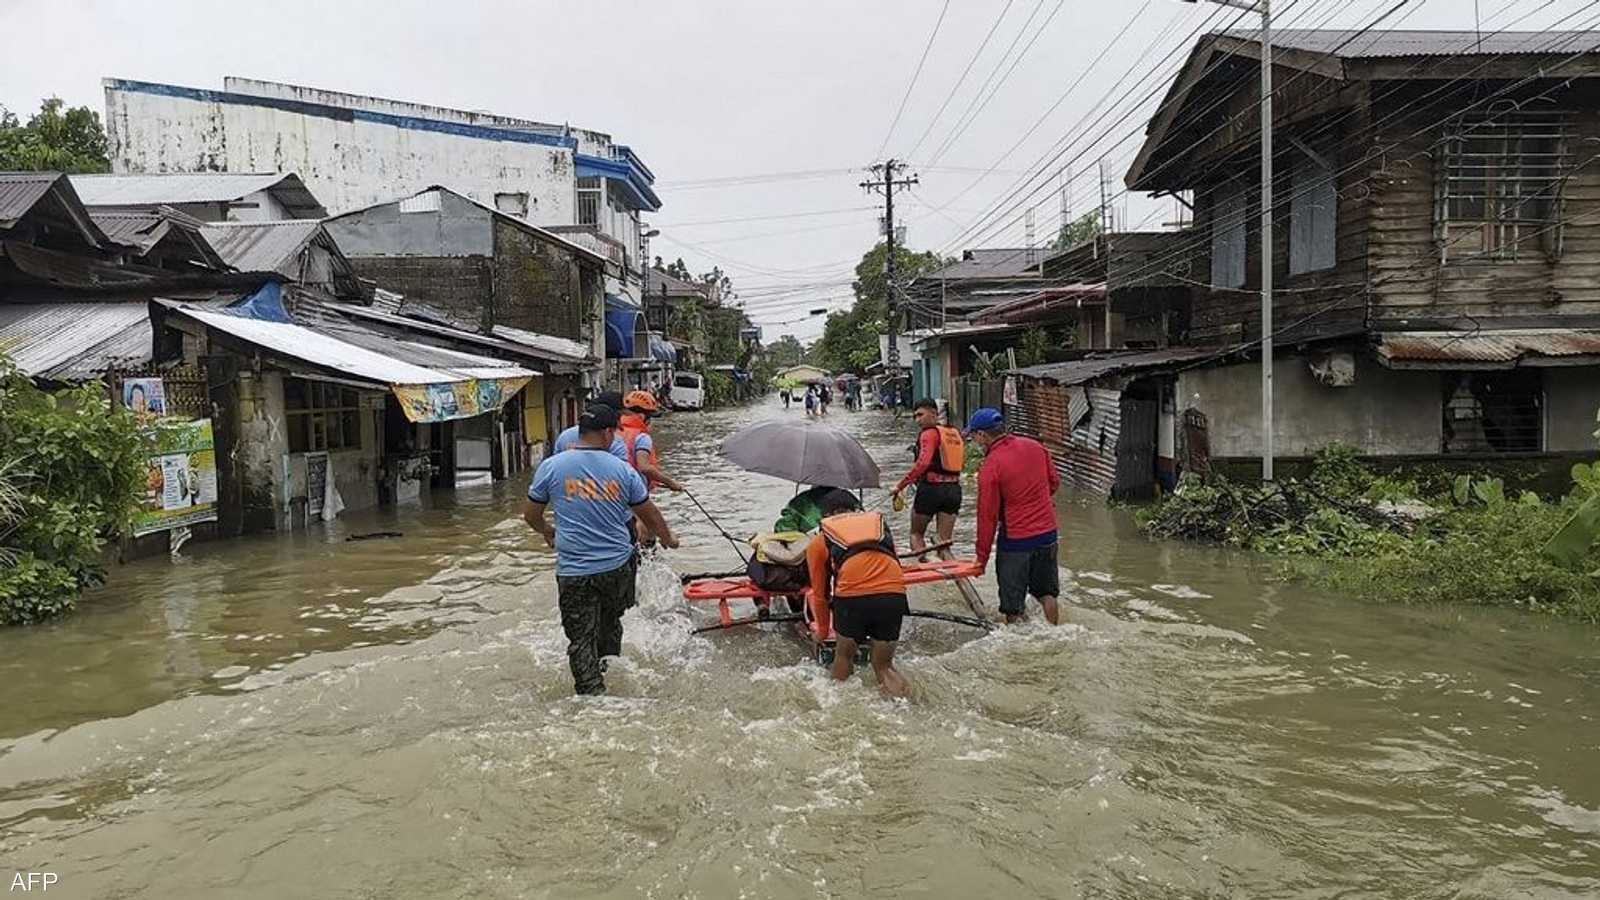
left=1005, top=378, right=1122, bottom=496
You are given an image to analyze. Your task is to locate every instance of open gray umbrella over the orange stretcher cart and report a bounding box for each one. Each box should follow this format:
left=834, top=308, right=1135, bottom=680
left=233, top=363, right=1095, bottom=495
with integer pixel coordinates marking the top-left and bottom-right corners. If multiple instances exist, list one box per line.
left=722, top=420, right=878, bottom=487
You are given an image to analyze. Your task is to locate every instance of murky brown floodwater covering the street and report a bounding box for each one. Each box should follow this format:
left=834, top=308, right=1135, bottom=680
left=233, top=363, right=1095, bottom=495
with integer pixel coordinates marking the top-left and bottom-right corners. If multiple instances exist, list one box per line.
left=0, top=399, right=1600, bottom=900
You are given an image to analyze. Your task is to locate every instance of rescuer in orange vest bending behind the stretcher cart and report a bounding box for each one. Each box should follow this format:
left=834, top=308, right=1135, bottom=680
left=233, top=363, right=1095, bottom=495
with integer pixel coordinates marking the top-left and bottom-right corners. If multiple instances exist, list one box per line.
left=806, top=490, right=910, bottom=697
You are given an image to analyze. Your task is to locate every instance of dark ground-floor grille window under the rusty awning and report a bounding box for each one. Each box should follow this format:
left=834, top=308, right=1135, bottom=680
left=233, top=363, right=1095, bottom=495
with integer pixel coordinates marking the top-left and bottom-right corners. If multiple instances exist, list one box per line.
left=1442, top=368, right=1544, bottom=453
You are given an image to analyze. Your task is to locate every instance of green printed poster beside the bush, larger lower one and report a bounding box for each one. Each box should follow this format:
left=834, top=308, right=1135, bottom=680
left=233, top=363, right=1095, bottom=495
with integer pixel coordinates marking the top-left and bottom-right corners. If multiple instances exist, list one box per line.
left=133, top=418, right=216, bottom=536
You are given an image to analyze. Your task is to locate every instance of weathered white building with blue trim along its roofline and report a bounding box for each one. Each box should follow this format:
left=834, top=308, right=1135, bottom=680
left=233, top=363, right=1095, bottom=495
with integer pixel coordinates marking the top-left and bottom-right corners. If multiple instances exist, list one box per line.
left=104, top=77, right=661, bottom=356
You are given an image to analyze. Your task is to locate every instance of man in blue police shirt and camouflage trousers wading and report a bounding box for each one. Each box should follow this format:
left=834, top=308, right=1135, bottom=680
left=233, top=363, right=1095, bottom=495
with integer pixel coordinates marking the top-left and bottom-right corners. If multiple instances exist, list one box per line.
left=522, top=404, right=678, bottom=693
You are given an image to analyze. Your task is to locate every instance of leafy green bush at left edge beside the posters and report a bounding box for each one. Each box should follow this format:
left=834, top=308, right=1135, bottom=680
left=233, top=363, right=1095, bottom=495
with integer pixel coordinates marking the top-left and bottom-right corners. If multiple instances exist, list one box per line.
left=0, top=356, right=146, bottom=625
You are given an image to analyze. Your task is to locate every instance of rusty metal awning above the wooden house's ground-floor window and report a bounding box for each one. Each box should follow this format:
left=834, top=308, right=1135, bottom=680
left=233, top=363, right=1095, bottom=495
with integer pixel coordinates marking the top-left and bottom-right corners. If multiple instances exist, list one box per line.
left=1378, top=328, right=1600, bottom=368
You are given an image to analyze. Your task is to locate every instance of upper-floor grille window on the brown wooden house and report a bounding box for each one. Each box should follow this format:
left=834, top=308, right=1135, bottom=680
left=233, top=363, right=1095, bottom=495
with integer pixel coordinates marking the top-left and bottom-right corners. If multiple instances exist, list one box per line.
left=1435, top=110, right=1570, bottom=263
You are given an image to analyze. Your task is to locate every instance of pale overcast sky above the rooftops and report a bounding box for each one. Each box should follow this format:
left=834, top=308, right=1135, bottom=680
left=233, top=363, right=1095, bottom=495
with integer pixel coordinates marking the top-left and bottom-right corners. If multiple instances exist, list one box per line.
left=0, top=0, right=1574, bottom=340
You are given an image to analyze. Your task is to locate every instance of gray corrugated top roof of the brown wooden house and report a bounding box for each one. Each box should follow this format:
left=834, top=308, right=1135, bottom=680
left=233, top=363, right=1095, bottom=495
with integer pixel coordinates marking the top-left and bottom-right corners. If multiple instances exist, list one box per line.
left=1227, top=29, right=1600, bottom=59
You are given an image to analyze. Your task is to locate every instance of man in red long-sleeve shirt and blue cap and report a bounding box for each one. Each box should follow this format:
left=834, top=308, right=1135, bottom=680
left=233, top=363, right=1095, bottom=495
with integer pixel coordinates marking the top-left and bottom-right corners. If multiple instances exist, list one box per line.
left=966, top=407, right=1061, bottom=625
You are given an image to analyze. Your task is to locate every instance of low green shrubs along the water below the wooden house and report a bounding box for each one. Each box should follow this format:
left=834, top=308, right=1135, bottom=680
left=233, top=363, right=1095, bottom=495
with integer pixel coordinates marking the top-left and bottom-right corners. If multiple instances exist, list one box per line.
left=1138, top=447, right=1600, bottom=621
